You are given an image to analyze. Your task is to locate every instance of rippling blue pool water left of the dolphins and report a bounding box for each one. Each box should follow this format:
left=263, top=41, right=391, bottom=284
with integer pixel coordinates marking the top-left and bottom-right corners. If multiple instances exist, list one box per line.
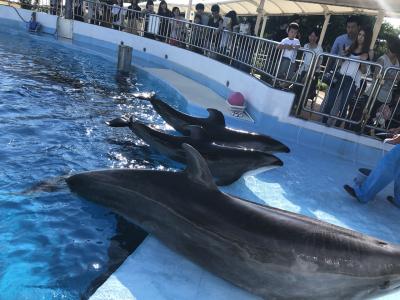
left=0, top=28, right=188, bottom=299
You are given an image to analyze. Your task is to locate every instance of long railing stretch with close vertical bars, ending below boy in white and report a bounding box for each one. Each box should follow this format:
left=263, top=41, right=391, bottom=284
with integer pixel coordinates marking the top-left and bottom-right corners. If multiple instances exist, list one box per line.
left=74, top=0, right=314, bottom=98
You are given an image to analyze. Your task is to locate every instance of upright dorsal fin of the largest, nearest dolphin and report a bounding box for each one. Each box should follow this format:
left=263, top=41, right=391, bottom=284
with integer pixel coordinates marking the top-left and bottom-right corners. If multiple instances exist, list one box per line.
left=182, top=143, right=218, bottom=190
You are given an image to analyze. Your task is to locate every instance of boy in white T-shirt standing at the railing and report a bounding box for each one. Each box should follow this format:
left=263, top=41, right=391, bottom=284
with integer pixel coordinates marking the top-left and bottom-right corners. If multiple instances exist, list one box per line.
left=277, top=23, right=300, bottom=80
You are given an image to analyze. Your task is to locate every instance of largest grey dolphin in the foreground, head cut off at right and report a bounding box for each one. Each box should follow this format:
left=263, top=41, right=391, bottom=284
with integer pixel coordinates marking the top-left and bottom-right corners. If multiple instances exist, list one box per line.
left=67, top=145, right=400, bottom=299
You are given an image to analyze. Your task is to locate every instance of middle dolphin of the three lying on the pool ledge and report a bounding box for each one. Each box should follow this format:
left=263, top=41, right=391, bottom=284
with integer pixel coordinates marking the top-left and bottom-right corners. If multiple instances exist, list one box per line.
left=107, top=117, right=283, bottom=185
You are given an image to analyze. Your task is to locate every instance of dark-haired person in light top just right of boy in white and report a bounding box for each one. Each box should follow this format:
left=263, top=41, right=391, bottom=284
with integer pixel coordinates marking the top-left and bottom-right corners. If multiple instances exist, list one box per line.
left=293, top=28, right=324, bottom=108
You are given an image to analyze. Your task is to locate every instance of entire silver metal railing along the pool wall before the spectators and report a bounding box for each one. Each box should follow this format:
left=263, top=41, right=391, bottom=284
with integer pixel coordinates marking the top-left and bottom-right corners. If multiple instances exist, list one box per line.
left=3, top=0, right=400, bottom=137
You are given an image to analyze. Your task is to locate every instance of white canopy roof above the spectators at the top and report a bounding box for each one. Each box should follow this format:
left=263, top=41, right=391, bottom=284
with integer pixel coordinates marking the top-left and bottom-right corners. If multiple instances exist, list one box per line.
left=141, top=0, right=400, bottom=17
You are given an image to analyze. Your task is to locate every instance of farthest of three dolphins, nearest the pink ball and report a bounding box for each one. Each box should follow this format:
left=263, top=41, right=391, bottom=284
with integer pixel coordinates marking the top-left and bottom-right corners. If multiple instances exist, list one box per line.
left=135, top=93, right=290, bottom=153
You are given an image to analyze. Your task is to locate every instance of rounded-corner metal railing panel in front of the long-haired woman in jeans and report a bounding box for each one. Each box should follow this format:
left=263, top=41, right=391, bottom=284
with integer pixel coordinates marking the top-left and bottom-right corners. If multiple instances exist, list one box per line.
left=300, top=53, right=383, bottom=132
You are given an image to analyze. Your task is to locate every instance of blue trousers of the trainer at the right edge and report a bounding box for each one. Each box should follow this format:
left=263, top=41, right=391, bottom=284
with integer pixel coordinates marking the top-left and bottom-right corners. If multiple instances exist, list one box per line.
left=354, top=145, right=400, bottom=206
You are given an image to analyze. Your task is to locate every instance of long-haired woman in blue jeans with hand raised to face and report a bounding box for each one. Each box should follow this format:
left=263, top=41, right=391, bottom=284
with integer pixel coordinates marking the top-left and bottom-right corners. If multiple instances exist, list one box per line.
left=322, top=29, right=372, bottom=125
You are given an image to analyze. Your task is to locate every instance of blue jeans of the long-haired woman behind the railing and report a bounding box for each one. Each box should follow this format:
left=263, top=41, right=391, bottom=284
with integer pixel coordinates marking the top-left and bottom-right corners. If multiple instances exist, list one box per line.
left=322, top=74, right=356, bottom=123
